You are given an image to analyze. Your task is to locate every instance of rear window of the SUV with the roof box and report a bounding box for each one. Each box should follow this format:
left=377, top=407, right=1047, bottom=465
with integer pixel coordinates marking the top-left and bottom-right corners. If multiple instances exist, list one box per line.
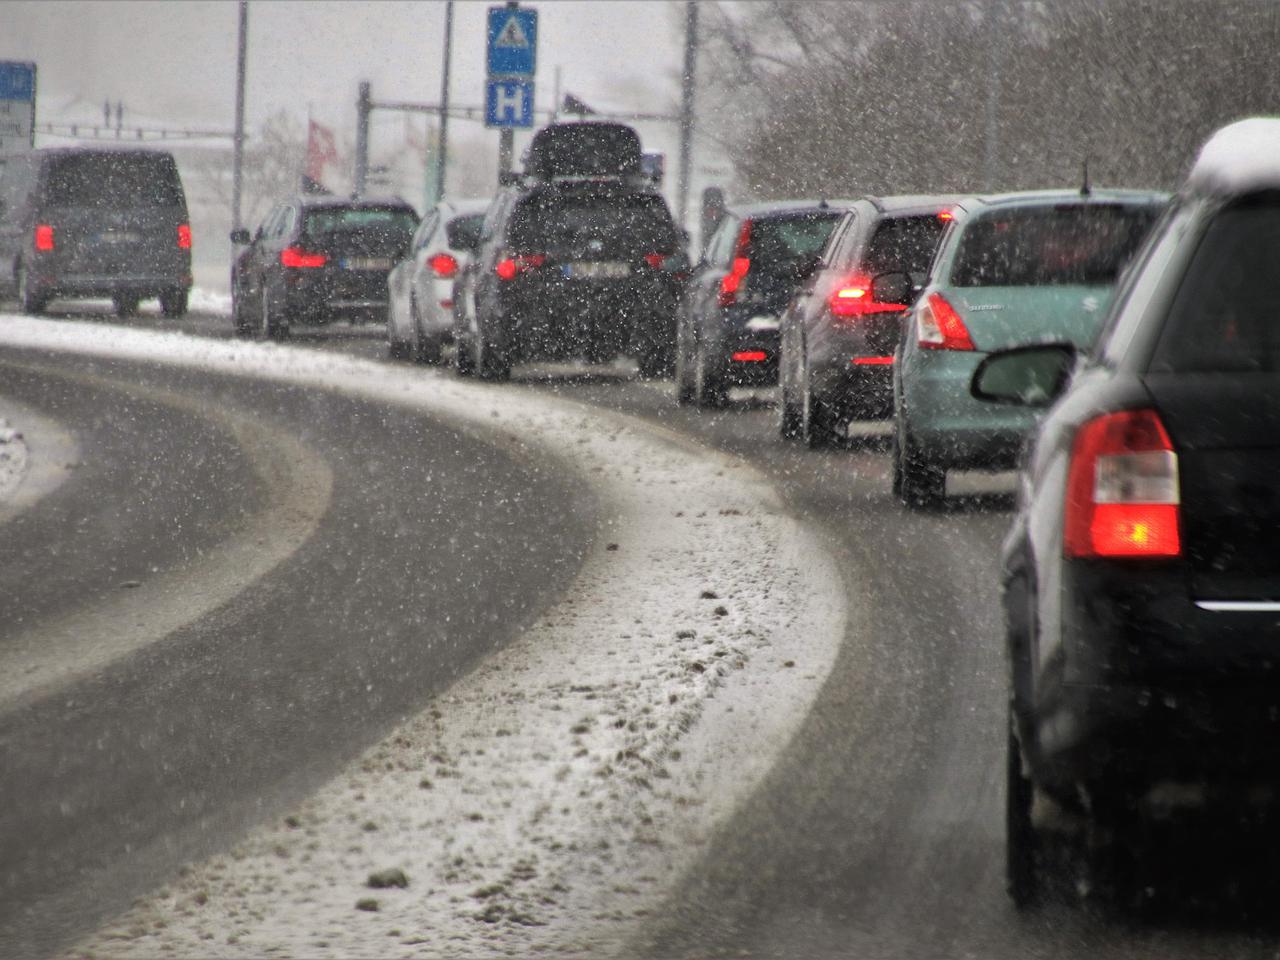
left=508, top=196, right=676, bottom=253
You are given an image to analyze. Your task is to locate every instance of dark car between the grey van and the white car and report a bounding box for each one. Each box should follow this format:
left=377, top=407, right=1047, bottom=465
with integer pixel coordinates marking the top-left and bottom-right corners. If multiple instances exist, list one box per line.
left=232, top=196, right=417, bottom=339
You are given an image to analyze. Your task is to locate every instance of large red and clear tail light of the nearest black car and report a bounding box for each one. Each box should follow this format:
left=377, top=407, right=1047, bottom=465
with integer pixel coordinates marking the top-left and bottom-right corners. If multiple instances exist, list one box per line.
left=1062, top=410, right=1181, bottom=557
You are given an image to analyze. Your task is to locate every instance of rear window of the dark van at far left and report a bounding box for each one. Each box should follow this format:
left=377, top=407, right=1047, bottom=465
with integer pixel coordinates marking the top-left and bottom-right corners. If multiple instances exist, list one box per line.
left=45, top=152, right=184, bottom=210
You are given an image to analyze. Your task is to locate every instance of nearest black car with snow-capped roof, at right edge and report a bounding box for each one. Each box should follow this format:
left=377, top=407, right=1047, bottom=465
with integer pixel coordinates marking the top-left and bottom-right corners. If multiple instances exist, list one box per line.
left=972, top=119, right=1280, bottom=904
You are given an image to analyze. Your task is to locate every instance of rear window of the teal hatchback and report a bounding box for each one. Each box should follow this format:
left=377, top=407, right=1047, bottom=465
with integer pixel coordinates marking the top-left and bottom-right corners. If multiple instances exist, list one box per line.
left=951, top=204, right=1160, bottom=287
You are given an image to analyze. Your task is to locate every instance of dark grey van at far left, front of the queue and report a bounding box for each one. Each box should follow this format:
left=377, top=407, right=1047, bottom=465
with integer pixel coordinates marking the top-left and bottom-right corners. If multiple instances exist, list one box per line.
left=0, top=147, right=191, bottom=317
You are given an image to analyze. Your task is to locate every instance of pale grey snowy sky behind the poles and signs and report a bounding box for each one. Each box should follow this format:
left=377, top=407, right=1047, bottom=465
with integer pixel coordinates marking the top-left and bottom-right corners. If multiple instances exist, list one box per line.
left=0, top=0, right=682, bottom=148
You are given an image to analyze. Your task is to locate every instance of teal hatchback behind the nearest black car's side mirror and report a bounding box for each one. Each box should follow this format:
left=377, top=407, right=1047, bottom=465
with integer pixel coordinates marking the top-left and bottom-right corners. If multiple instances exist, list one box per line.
left=883, top=188, right=1169, bottom=507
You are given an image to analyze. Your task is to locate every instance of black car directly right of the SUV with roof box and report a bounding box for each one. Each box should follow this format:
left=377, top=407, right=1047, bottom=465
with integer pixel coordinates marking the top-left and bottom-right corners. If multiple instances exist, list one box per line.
left=676, top=200, right=844, bottom=407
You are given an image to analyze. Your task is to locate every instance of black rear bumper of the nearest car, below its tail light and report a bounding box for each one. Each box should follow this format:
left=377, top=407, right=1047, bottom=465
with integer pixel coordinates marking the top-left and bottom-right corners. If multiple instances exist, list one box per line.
left=1037, top=561, right=1280, bottom=787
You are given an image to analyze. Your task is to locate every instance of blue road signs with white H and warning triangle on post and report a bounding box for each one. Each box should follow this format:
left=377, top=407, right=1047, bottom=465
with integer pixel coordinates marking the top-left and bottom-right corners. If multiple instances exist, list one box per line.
left=484, top=3, right=538, bottom=175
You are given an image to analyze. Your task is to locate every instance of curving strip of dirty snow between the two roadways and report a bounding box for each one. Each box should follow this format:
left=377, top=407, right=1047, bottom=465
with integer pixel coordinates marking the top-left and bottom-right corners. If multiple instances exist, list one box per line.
left=0, top=316, right=845, bottom=957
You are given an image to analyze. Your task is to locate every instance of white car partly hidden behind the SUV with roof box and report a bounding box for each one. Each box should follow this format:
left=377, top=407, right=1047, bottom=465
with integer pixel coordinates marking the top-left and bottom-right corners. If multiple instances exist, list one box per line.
left=387, top=200, right=489, bottom=364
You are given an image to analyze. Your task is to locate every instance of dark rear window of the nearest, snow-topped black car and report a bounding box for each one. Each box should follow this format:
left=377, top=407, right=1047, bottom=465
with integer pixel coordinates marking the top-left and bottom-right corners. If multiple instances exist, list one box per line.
left=1152, top=195, right=1280, bottom=372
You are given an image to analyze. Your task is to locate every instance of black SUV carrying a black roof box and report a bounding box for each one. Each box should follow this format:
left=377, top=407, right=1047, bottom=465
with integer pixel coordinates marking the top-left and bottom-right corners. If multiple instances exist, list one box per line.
left=453, top=123, right=689, bottom=379
